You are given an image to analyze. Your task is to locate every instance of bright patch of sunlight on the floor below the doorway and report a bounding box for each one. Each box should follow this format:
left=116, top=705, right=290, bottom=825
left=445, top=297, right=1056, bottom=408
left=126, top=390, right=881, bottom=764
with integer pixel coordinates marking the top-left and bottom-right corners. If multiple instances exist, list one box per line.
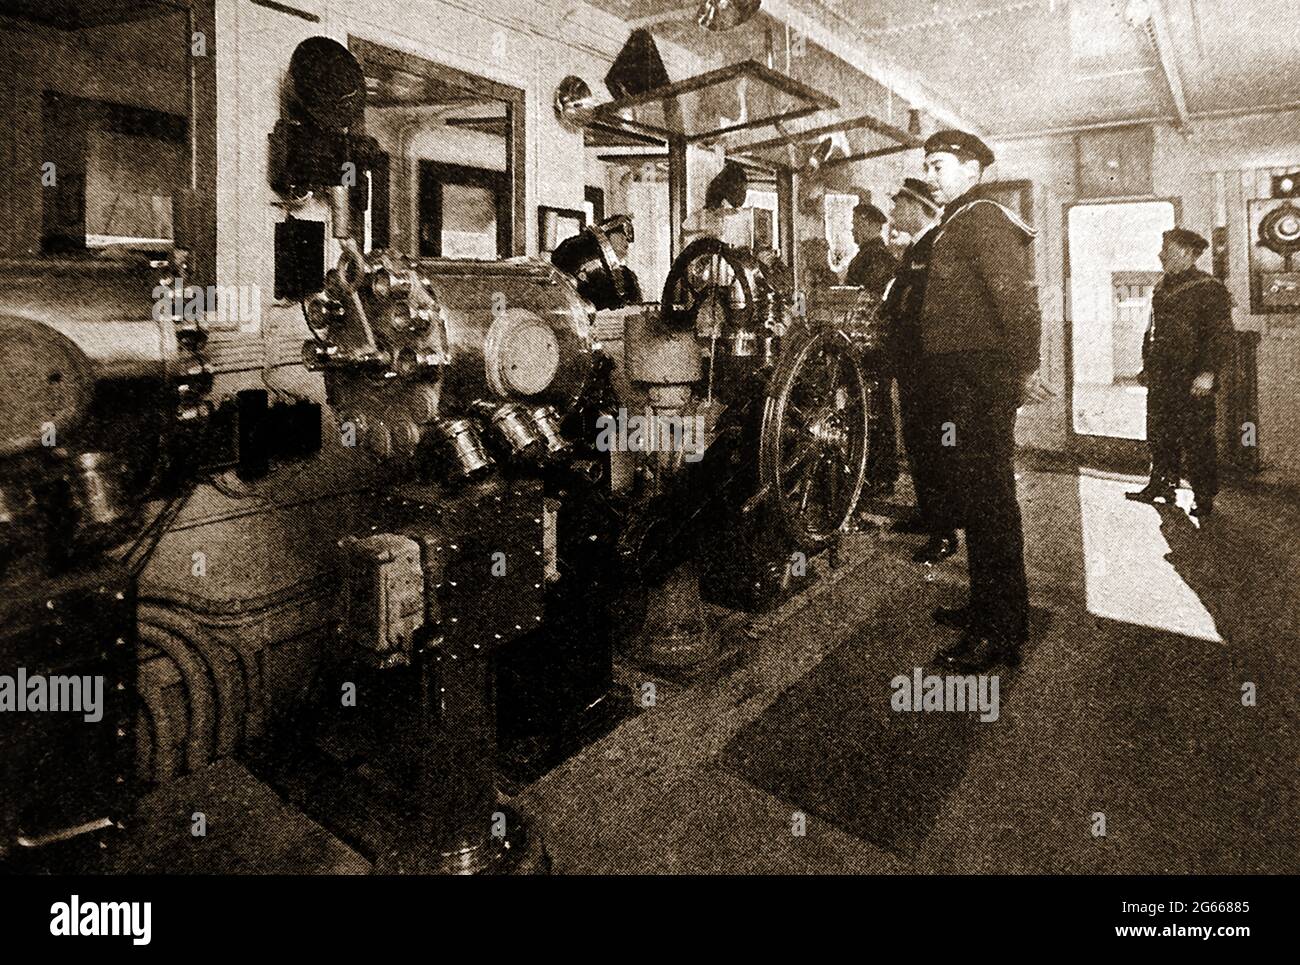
left=1079, top=476, right=1223, bottom=642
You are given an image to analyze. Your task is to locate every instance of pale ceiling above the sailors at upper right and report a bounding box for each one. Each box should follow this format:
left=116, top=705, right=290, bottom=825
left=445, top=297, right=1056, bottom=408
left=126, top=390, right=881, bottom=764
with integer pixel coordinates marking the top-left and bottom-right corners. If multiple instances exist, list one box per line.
left=597, top=0, right=1300, bottom=134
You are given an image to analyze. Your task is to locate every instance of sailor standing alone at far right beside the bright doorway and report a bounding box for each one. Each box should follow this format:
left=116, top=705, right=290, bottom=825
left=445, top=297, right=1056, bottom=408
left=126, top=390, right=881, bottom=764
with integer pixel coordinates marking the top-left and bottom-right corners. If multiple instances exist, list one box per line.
left=1127, top=228, right=1232, bottom=519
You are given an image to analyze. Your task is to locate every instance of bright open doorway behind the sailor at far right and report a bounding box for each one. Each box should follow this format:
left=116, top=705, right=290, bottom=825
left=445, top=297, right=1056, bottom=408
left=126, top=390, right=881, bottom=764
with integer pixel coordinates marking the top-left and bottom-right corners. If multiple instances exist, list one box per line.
left=1066, top=200, right=1177, bottom=442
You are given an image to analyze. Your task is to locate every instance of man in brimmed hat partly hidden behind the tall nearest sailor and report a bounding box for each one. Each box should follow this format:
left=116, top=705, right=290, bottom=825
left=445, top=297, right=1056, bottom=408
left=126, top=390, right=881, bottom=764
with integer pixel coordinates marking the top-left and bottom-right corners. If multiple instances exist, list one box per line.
left=881, top=178, right=957, bottom=564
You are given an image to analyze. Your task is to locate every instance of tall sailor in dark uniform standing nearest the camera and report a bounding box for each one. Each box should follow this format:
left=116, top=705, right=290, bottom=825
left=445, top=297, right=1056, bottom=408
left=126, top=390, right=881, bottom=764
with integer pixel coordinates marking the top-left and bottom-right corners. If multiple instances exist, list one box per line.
left=922, top=130, right=1047, bottom=671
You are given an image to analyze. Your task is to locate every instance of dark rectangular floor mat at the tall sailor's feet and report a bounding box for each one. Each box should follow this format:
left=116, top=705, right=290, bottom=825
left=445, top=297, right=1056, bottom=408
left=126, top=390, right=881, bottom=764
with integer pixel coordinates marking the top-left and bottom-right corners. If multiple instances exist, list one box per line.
left=720, top=610, right=1049, bottom=858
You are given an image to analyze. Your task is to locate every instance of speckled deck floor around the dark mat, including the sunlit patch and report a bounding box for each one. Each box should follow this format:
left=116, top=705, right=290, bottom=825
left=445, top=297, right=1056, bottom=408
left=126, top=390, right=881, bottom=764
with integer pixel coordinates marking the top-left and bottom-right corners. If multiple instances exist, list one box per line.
left=516, top=469, right=1300, bottom=873
